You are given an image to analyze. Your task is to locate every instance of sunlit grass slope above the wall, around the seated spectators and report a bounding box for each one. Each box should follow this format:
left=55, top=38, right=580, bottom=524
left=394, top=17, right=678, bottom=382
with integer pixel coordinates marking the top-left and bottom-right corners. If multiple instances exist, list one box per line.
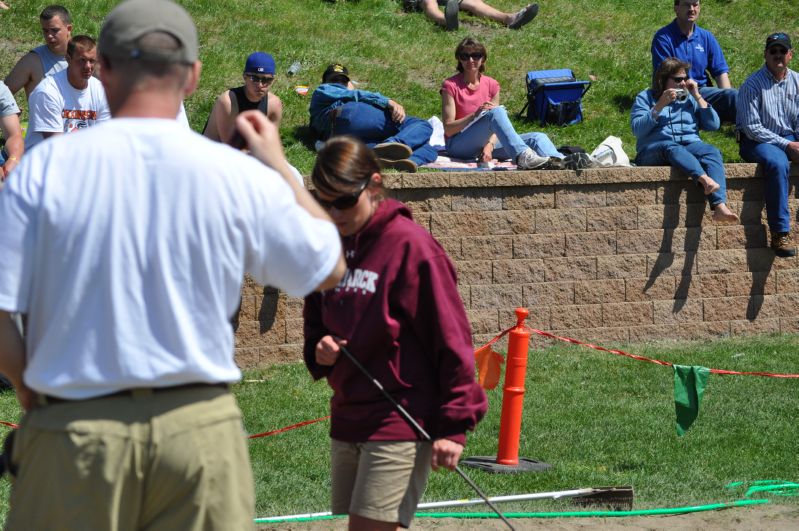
left=0, top=0, right=799, bottom=173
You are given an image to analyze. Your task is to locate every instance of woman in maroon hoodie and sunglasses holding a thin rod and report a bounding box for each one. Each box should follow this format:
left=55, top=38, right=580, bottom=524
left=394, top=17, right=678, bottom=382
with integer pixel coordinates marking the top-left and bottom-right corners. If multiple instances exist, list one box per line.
left=304, top=137, right=488, bottom=529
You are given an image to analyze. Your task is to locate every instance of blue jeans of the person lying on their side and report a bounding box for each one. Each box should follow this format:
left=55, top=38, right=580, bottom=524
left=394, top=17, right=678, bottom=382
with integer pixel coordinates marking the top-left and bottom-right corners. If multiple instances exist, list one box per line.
left=330, top=101, right=438, bottom=166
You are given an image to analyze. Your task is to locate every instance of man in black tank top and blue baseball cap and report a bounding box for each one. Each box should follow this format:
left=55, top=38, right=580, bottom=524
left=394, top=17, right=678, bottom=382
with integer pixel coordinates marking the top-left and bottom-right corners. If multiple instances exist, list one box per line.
left=203, top=52, right=283, bottom=142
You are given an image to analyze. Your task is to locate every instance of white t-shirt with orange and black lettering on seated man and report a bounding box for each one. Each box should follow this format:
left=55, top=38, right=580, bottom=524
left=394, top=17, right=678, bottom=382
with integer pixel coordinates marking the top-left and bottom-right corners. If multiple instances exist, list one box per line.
left=25, top=70, right=111, bottom=151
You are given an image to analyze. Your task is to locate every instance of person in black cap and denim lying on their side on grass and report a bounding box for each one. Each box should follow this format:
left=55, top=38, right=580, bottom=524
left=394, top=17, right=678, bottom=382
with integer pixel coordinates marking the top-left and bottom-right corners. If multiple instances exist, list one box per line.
left=308, top=64, right=438, bottom=173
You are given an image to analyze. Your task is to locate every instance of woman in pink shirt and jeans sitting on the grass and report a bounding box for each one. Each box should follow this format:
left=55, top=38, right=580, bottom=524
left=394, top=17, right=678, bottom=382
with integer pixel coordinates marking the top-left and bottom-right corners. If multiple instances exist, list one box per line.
left=441, top=37, right=563, bottom=170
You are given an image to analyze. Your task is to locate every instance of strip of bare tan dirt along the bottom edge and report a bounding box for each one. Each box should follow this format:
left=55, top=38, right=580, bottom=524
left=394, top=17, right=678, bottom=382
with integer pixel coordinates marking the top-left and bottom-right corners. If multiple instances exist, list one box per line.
left=259, top=503, right=799, bottom=531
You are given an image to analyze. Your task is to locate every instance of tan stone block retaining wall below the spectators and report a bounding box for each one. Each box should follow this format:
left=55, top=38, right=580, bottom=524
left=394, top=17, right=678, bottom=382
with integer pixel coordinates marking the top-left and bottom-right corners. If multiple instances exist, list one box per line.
left=236, top=164, right=799, bottom=367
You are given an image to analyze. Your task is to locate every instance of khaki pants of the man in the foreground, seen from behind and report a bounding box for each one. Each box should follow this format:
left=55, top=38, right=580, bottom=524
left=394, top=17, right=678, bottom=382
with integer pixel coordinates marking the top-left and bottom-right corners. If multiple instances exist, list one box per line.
left=6, top=387, right=255, bottom=531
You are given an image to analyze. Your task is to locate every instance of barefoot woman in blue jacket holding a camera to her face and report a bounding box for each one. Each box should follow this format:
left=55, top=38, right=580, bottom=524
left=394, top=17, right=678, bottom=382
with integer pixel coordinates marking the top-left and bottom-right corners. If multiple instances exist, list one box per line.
left=630, top=57, right=738, bottom=223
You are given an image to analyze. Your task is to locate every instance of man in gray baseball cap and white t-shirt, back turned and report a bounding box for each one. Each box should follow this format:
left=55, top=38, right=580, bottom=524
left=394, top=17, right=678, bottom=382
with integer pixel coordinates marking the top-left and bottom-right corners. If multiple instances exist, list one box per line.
left=0, top=0, right=345, bottom=531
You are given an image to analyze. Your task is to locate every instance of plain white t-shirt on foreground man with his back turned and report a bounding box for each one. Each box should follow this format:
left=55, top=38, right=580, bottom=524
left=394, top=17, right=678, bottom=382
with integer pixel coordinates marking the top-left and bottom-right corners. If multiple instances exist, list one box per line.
left=0, top=118, right=341, bottom=399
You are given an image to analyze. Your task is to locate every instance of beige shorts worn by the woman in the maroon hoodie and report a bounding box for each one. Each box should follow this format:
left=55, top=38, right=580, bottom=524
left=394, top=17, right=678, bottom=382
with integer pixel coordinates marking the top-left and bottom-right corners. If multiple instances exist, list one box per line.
left=330, top=439, right=432, bottom=527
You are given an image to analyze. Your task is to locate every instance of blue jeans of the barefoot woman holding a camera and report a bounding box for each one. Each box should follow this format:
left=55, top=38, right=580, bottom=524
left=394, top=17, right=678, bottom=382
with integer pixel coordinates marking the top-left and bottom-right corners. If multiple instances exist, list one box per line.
left=635, top=142, right=727, bottom=208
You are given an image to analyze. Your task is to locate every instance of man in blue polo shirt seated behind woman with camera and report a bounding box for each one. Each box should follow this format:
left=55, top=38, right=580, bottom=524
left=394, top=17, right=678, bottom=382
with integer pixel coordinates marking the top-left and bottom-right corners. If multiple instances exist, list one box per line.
left=652, top=0, right=738, bottom=124
